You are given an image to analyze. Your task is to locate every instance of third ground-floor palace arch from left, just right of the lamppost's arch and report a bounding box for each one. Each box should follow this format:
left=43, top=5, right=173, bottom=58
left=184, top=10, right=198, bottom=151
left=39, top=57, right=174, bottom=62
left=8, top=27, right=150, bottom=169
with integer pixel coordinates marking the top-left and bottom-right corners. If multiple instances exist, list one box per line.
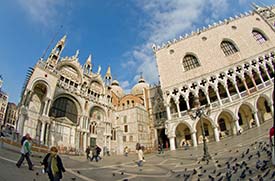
left=217, top=111, right=234, bottom=139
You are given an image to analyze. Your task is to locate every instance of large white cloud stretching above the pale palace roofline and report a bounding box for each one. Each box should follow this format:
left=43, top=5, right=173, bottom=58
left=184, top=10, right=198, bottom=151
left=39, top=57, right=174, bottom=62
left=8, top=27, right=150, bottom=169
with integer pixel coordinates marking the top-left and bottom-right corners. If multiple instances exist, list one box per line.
left=123, top=0, right=229, bottom=87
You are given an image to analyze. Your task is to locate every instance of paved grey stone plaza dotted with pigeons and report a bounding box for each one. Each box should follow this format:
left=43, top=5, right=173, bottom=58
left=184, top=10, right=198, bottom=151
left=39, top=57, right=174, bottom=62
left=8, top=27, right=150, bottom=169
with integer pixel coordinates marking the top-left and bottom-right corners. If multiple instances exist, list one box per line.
left=0, top=120, right=275, bottom=181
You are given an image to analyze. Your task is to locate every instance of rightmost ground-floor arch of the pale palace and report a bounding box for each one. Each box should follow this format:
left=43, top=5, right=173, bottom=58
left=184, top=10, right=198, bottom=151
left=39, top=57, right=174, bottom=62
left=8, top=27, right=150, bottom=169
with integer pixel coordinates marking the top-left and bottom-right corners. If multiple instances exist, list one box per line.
left=257, top=97, right=272, bottom=123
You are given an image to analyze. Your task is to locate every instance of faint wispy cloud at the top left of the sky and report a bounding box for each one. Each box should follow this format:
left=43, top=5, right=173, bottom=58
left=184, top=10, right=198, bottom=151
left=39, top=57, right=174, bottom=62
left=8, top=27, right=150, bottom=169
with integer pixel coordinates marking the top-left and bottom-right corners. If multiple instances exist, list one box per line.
left=18, top=0, right=70, bottom=26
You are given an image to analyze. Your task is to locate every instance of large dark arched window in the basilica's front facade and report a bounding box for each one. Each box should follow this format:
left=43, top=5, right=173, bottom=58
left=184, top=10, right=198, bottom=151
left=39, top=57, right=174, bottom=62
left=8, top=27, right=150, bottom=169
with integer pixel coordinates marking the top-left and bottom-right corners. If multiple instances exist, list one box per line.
left=50, top=97, right=77, bottom=123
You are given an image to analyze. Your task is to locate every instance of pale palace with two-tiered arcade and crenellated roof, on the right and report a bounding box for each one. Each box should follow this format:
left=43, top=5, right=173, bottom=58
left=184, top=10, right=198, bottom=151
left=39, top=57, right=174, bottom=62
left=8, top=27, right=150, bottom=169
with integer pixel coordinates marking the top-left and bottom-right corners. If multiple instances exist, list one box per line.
left=152, top=5, right=275, bottom=150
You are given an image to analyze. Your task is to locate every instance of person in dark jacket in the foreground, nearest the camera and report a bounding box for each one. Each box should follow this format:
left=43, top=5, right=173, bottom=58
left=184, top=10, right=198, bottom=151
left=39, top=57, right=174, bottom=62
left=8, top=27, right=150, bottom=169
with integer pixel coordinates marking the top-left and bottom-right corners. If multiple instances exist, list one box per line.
left=42, top=146, right=66, bottom=181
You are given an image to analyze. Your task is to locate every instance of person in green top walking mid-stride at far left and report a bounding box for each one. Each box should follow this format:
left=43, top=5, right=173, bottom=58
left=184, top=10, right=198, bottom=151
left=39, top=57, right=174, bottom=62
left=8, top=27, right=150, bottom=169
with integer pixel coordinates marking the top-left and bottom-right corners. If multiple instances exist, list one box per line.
left=16, top=134, right=33, bottom=170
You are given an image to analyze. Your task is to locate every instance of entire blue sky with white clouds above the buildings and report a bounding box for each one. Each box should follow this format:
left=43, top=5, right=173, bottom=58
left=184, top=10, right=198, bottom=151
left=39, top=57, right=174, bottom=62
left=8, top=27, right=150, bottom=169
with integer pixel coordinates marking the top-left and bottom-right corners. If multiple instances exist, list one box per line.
left=0, top=0, right=275, bottom=103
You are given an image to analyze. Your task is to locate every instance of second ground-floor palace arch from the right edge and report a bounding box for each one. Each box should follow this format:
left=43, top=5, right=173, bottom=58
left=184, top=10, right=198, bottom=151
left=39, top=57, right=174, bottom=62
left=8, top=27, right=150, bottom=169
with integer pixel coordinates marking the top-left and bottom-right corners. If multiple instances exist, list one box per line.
left=238, top=104, right=255, bottom=130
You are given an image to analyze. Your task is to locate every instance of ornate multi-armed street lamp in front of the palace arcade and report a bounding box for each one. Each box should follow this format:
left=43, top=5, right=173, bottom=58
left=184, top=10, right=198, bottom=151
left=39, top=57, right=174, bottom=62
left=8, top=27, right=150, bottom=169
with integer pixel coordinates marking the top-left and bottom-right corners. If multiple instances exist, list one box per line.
left=188, top=97, right=211, bottom=161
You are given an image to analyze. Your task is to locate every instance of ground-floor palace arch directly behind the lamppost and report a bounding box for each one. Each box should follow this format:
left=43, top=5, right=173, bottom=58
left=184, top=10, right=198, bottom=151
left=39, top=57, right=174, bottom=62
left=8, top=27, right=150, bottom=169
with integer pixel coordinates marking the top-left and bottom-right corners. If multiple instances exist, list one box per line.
left=196, top=118, right=215, bottom=144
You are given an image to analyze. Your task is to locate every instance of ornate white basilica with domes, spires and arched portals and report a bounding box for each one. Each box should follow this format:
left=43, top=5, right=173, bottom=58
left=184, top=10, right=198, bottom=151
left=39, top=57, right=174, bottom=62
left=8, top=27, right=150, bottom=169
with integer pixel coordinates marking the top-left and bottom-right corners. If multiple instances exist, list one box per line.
left=17, top=36, right=154, bottom=154
